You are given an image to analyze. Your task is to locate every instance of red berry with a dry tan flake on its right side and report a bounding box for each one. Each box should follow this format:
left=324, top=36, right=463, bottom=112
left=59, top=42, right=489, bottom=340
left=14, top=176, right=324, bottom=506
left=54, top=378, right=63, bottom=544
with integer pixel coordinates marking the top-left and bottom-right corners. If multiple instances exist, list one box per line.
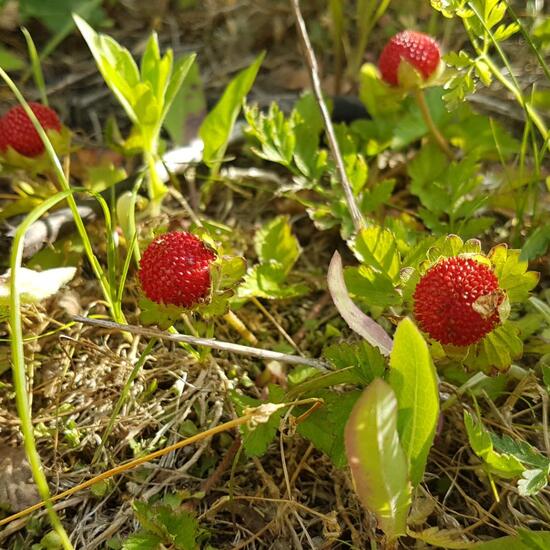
left=413, top=256, right=504, bottom=346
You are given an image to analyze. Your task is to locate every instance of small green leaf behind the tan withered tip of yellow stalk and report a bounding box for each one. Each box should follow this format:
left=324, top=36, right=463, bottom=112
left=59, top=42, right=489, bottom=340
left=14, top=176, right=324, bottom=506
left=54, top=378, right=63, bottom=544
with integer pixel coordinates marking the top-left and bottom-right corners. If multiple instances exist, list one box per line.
left=229, top=384, right=284, bottom=457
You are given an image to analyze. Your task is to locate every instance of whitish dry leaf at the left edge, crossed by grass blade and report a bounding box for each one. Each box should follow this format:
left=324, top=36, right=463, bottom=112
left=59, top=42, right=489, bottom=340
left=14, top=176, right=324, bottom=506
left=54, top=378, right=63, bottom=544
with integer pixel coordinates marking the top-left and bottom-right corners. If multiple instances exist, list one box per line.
left=0, top=267, right=76, bottom=306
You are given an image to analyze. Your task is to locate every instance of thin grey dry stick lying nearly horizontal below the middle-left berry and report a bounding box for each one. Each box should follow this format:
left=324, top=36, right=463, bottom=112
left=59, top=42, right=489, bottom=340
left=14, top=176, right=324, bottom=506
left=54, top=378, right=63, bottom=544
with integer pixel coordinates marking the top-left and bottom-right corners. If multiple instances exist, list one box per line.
left=73, top=315, right=328, bottom=371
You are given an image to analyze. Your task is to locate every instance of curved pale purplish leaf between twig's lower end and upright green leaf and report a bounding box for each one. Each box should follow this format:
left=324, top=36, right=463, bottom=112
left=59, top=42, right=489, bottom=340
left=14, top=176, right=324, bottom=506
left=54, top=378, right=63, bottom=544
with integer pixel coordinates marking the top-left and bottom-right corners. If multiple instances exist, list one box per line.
left=327, top=252, right=393, bottom=355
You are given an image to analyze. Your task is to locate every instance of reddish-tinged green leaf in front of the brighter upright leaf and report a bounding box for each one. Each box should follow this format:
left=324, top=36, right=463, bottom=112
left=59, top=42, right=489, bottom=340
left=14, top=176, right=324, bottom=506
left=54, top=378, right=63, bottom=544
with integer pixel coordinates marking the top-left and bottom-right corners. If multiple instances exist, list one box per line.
left=345, top=378, right=411, bottom=540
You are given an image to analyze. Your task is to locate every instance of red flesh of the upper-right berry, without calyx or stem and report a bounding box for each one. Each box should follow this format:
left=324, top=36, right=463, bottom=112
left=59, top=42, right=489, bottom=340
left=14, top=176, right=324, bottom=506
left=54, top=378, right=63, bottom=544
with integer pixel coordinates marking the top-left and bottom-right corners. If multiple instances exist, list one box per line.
left=378, top=31, right=441, bottom=86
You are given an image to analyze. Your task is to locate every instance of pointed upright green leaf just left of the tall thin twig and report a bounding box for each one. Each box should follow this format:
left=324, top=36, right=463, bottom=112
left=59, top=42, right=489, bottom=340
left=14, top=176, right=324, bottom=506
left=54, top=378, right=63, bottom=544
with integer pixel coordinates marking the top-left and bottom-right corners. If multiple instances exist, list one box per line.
left=199, top=53, right=265, bottom=165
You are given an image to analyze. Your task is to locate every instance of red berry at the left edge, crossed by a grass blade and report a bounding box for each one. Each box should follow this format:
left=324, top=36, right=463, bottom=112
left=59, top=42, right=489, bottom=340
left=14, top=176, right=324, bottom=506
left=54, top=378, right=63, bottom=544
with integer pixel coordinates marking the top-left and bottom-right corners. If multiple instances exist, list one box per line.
left=2, top=103, right=61, bottom=157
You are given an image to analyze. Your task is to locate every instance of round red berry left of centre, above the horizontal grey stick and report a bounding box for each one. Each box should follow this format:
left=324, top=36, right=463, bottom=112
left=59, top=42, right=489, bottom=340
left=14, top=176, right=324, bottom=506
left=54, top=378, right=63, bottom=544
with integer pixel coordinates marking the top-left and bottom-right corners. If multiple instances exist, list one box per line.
left=139, top=231, right=216, bottom=307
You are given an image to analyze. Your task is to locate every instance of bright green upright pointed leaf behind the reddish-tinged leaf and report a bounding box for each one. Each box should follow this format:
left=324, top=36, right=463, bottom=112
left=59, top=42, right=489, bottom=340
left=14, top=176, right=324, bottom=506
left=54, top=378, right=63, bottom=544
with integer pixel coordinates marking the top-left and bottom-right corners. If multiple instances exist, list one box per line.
left=388, top=317, right=439, bottom=486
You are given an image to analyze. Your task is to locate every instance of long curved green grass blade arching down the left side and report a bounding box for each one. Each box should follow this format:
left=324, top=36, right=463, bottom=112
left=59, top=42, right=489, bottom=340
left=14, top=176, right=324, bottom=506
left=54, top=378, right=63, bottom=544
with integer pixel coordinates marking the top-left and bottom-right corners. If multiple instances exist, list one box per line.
left=8, top=192, right=73, bottom=550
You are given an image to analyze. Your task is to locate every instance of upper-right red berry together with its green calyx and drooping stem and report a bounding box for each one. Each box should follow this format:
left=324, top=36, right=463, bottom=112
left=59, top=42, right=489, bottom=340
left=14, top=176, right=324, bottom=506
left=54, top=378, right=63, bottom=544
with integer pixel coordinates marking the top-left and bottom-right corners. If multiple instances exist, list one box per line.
left=378, top=31, right=454, bottom=160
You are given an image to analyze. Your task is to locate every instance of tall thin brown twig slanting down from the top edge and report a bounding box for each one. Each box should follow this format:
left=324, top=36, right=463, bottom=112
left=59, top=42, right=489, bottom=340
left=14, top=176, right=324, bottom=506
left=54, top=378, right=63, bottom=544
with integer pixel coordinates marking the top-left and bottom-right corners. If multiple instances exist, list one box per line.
left=290, top=0, right=365, bottom=231
